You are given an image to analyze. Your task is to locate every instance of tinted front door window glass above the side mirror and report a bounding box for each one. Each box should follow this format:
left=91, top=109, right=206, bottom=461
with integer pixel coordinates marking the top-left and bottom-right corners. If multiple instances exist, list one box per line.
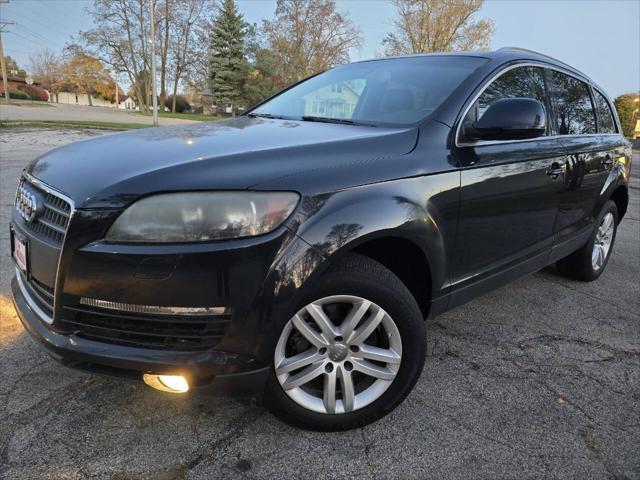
left=464, top=67, right=546, bottom=122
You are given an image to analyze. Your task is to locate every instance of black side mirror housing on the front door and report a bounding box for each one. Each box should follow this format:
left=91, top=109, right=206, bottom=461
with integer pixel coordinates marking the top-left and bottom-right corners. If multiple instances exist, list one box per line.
left=463, top=98, right=547, bottom=140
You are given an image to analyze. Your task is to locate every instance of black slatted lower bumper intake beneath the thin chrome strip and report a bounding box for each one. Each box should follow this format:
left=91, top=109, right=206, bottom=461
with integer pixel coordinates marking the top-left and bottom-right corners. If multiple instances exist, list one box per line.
left=58, top=305, right=231, bottom=350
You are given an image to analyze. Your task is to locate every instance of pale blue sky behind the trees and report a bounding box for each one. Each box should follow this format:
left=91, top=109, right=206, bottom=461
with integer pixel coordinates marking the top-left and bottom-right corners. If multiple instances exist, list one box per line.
left=0, top=0, right=640, bottom=96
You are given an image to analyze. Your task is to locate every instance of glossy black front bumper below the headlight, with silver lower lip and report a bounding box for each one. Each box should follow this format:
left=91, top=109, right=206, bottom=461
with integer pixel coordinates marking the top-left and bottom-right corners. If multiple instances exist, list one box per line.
left=11, top=174, right=324, bottom=393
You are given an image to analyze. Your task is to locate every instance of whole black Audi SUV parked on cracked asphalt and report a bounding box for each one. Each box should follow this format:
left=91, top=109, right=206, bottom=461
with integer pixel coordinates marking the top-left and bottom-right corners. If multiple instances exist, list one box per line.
left=11, top=49, right=631, bottom=430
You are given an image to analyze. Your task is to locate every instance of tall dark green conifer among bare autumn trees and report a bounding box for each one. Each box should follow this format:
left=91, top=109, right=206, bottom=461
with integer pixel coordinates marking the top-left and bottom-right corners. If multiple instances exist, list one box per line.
left=209, top=0, right=248, bottom=105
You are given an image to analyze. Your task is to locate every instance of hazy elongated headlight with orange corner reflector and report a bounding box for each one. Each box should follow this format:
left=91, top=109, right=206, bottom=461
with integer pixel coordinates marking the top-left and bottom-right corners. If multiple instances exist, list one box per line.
left=106, top=192, right=300, bottom=243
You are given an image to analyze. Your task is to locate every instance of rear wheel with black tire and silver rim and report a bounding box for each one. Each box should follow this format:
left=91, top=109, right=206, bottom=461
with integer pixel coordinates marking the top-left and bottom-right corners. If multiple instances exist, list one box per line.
left=556, top=200, right=618, bottom=282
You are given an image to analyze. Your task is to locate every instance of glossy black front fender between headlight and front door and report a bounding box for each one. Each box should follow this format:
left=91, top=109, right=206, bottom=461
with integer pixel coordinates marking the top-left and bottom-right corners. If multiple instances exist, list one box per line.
left=294, top=172, right=460, bottom=298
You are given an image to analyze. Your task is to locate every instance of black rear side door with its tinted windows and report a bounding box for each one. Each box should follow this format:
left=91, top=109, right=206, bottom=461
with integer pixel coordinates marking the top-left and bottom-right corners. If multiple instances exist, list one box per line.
left=547, top=70, right=618, bottom=260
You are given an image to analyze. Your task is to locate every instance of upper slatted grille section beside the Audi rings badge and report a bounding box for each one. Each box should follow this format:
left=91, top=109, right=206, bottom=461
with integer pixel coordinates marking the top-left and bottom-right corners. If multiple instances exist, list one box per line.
left=16, top=178, right=71, bottom=245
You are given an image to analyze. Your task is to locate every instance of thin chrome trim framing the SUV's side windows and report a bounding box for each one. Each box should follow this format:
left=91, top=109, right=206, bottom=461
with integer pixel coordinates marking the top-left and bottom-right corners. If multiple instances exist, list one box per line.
left=455, top=61, right=620, bottom=147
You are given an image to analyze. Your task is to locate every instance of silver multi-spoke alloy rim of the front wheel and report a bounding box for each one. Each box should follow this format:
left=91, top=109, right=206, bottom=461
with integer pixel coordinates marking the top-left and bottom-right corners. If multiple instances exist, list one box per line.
left=274, top=295, right=402, bottom=414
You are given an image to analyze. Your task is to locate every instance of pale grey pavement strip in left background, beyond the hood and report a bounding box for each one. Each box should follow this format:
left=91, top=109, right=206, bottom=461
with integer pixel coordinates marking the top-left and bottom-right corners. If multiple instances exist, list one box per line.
left=0, top=102, right=196, bottom=125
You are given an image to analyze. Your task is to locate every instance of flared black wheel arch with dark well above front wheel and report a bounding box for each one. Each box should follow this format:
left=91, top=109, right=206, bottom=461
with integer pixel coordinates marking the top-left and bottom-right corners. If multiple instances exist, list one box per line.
left=297, top=191, right=447, bottom=317
